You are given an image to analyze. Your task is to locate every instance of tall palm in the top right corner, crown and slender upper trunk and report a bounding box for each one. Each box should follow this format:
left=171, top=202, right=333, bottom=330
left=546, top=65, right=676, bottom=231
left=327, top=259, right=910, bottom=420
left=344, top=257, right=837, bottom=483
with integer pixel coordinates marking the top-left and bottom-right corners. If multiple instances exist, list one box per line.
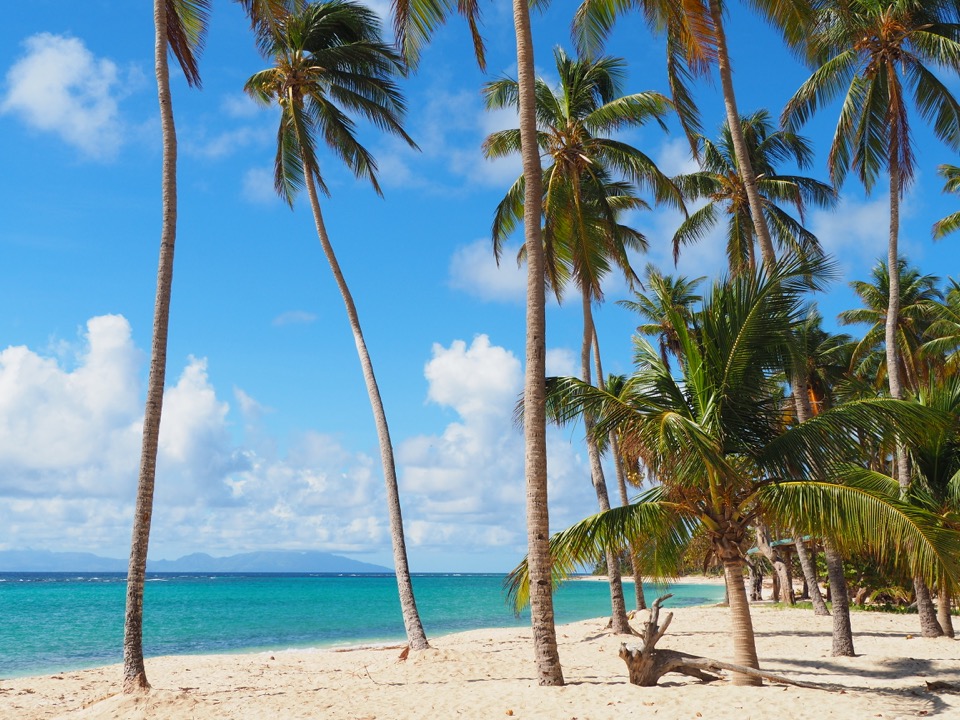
left=783, top=0, right=960, bottom=512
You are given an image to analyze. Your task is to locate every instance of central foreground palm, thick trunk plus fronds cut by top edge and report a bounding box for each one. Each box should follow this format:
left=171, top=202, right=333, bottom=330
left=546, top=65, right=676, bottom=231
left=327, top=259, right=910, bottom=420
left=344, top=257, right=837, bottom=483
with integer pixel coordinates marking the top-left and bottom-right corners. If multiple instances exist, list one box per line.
left=391, top=0, right=563, bottom=686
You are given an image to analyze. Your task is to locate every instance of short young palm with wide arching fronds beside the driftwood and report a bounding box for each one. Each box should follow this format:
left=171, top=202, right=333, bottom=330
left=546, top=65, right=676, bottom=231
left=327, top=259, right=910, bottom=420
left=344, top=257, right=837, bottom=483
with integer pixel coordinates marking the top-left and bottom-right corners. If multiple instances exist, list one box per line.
left=513, top=264, right=957, bottom=683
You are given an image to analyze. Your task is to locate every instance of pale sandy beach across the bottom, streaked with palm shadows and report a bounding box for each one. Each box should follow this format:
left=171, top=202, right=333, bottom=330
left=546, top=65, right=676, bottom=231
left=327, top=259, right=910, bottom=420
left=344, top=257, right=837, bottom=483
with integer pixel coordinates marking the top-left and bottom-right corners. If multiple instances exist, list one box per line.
left=0, top=604, right=960, bottom=720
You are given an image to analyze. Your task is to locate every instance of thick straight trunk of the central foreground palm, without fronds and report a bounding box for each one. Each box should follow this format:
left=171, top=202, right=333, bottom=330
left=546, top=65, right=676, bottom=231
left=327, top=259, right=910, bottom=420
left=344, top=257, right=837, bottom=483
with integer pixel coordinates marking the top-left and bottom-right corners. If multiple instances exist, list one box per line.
left=513, top=0, right=563, bottom=685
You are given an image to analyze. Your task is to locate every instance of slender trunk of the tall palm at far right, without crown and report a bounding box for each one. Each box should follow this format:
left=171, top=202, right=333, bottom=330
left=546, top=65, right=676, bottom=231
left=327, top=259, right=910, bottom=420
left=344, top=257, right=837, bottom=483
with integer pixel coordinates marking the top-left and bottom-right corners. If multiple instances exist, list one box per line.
left=884, top=143, right=943, bottom=637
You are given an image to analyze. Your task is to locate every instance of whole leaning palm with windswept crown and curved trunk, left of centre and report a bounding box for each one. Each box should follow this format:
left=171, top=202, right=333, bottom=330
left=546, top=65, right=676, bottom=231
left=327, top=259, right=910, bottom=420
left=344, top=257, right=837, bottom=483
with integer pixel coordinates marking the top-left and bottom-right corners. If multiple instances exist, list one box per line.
left=244, top=0, right=428, bottom=650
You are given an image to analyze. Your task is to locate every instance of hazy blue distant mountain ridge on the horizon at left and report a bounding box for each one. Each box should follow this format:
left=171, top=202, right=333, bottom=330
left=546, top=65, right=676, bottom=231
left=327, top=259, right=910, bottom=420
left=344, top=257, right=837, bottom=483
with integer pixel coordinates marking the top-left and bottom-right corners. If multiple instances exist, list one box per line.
left=0, top=550, right=393, bottom=573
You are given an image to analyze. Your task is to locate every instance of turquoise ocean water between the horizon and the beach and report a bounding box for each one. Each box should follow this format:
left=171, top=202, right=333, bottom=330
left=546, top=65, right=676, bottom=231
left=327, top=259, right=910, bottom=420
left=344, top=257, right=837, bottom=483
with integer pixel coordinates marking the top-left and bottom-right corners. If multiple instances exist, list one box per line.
left=0, top=573, right=723, bottom=678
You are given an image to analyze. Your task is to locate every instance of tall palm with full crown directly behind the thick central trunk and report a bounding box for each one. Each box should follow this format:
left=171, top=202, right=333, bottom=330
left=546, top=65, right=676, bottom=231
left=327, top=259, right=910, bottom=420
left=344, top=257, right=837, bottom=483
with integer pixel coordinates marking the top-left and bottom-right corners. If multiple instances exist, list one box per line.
left=484, top=48, right=682, bottom=633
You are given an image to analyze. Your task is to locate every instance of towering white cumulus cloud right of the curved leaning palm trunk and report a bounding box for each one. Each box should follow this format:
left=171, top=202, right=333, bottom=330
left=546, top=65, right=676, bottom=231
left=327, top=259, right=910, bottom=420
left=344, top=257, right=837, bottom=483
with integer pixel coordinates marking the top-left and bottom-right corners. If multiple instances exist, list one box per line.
left=398, top=335, right=592, bottom=553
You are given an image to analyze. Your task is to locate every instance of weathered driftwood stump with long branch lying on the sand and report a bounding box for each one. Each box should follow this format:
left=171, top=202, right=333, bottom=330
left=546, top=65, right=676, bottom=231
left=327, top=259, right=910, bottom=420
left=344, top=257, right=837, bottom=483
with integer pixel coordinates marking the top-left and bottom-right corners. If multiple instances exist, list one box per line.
left=620, top=594, right=826, bottom=690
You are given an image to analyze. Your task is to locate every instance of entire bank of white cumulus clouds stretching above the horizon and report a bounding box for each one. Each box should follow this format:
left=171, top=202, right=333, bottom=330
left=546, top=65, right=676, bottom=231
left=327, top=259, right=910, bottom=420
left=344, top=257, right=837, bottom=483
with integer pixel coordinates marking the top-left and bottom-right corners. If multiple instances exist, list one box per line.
left=0, top=316, right=608, bottom=569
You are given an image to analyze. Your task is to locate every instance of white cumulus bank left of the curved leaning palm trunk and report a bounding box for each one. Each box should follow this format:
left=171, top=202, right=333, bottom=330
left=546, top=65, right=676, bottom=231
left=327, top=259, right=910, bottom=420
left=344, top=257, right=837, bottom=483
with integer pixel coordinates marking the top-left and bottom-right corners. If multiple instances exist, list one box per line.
left=0, top=315, right=394, bottom=557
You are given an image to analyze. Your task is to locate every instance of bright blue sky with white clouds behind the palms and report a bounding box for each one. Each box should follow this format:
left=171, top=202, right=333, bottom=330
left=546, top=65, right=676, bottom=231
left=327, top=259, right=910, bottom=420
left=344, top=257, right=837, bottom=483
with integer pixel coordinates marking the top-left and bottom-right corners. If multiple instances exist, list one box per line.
left=0, top=0, right=960, bottom=572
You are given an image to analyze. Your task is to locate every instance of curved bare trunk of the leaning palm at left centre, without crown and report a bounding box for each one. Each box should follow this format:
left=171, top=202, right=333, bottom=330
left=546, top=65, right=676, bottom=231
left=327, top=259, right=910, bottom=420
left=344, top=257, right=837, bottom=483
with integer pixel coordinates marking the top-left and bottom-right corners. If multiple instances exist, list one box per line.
left=303, top=163, right=430, bottom=650
